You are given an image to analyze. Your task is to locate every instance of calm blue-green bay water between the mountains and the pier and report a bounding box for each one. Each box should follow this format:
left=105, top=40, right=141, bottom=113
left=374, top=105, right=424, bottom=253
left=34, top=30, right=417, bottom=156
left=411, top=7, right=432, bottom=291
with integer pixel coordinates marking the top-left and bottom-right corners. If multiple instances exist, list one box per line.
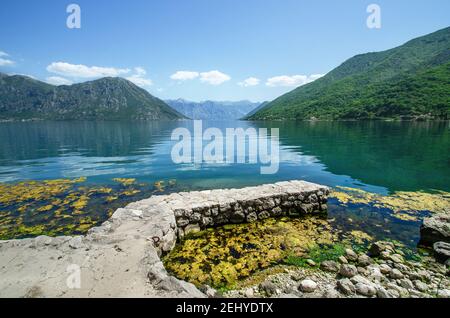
left=0, top=121, right=450, bottom=245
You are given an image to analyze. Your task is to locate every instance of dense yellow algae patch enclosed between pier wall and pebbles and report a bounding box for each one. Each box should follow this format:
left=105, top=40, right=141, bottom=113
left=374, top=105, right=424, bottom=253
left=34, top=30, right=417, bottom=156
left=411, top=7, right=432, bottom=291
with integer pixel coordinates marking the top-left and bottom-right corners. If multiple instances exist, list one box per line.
left=163, top=217, right=374, bottom=288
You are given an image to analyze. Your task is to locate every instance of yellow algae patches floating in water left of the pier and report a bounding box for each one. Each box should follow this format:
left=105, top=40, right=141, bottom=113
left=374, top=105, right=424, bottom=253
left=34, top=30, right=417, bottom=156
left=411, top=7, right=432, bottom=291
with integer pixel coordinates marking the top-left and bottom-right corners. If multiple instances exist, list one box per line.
left=0, top=177, right=179, bottom=239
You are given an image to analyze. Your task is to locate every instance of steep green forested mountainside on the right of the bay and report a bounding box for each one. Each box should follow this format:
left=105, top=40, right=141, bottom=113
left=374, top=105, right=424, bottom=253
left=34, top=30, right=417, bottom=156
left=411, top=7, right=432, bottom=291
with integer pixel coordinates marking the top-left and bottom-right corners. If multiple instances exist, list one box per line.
left=247, top=27, right=450, bottom=120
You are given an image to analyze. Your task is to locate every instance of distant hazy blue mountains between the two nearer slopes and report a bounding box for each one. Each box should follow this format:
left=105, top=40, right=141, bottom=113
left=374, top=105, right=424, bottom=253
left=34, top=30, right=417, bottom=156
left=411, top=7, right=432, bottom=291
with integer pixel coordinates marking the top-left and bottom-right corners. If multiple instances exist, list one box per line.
left=166, top=99, right=260, bottom=120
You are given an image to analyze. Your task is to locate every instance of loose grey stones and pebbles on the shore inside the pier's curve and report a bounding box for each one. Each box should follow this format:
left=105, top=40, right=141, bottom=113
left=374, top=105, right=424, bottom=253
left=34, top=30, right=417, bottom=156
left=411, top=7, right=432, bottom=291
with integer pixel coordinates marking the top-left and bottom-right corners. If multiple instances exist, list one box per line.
left=225, top=241, right=450, bottom=298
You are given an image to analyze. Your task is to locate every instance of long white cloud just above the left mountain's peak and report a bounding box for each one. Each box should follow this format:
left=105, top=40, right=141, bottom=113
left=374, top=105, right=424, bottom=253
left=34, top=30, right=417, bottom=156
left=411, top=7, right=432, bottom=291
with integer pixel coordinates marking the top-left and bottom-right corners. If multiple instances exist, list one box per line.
left=47, top=62, right=130, bottom=78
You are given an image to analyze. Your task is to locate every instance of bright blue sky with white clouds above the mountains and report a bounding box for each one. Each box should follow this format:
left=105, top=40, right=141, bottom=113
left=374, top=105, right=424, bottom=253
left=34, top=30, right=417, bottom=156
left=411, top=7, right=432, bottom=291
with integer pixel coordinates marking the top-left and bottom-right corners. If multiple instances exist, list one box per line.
left=0, top=0, right=450, bottom=101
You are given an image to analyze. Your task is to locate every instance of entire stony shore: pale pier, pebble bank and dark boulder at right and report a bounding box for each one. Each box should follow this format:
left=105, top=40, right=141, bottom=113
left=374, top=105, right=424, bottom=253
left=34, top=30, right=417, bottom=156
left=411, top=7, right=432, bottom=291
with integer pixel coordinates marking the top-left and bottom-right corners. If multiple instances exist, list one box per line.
left=0, top=181, right=450, bottom=298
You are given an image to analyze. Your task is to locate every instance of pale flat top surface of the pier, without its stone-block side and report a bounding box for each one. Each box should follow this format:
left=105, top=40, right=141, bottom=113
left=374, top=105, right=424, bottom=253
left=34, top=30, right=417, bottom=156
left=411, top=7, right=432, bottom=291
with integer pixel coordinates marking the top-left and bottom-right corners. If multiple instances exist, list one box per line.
left=0, top=181, right=328, bottom=298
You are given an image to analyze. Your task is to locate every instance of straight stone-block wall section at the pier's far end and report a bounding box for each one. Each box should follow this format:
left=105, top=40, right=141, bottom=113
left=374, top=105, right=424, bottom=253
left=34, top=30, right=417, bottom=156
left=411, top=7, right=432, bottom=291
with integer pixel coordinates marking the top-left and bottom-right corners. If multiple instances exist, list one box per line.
left=163, top=181, right=329, bottom=238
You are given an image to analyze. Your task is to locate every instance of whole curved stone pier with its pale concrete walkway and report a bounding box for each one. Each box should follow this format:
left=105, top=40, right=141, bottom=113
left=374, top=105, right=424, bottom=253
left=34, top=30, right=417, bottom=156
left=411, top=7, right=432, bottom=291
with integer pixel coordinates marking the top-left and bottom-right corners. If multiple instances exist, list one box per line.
left=0, top=181, right=329, bottom=297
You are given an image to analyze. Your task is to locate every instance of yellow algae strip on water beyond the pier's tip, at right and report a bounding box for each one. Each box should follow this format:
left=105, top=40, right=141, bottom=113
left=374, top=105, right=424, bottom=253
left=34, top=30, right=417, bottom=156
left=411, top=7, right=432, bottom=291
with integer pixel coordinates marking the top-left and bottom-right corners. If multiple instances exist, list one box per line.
left=330, top=187, right=450, bottom=221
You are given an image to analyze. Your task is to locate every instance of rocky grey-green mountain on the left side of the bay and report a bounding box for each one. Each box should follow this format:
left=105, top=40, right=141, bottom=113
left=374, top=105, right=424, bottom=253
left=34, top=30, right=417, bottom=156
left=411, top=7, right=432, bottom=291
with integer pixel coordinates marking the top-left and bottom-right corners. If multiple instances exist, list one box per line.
left=0, top=73, right=185, bottom=120
